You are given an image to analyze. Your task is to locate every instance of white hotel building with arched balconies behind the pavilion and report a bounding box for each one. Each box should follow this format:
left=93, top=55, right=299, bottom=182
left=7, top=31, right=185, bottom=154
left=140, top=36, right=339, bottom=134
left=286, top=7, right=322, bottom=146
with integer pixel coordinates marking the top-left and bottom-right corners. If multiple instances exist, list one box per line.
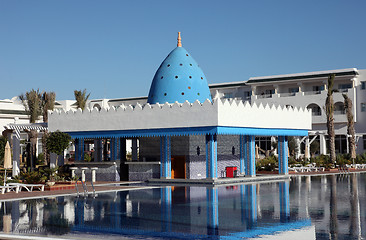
left=0, top=68, right=366, bottom=158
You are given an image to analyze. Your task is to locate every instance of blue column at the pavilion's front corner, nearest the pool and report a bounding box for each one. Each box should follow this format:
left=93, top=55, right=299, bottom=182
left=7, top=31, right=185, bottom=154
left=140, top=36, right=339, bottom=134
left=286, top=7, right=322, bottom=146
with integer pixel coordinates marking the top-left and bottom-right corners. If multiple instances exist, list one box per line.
left=206, top=134, right=217, bottom=179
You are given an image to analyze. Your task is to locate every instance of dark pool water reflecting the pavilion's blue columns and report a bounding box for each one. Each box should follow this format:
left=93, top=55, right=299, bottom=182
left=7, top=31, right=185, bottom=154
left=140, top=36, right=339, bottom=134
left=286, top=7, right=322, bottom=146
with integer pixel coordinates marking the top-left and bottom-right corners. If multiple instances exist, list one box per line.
left=0, top=173, right=366, bottom=239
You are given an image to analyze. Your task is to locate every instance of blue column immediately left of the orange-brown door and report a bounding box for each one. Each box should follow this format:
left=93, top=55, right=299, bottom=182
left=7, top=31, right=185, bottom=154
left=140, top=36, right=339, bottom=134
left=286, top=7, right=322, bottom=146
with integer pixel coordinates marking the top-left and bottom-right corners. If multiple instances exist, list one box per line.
left=160, top=136, right=172, bottom=179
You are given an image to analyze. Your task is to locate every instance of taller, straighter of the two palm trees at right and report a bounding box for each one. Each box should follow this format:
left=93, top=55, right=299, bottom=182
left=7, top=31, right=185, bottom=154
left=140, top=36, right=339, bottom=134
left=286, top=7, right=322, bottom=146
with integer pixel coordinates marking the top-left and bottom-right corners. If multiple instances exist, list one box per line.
left=325, top=74, right=336, bottom=163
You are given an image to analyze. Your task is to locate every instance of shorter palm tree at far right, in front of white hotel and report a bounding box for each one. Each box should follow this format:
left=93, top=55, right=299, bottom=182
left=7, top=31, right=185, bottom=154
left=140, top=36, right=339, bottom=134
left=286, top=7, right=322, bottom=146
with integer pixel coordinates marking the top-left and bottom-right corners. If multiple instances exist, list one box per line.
left=342, top=94, right=356, bottom=160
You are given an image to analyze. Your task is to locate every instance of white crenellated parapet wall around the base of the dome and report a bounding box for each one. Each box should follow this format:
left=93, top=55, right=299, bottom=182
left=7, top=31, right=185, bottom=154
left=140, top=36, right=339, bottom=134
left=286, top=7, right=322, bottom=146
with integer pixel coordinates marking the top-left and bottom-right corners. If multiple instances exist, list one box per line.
left=48, top=100, right=311, bottom=132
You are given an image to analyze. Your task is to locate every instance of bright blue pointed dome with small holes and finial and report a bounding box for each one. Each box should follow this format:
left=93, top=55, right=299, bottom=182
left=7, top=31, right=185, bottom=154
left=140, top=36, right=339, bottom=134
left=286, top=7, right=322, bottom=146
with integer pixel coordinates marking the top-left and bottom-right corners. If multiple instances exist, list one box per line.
left=147, top=33, right=211, bottom=104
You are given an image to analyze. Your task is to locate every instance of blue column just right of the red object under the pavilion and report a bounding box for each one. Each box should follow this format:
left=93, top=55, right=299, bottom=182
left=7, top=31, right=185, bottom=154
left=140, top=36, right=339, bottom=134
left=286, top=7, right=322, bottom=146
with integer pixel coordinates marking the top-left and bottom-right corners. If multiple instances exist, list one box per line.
left=243, top=135, right=256, bottom=177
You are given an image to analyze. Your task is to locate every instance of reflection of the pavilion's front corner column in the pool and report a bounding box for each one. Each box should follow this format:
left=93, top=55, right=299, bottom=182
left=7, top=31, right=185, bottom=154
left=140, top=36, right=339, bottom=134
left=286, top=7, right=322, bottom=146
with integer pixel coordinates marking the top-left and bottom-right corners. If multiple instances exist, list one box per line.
left=206, top=187, right=219, bottom=235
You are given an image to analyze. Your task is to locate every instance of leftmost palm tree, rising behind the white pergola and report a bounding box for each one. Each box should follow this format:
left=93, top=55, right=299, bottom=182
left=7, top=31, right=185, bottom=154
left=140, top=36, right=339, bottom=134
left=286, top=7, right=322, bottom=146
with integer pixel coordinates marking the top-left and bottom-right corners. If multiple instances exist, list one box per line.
left=19, top=89, right=42, bottom=171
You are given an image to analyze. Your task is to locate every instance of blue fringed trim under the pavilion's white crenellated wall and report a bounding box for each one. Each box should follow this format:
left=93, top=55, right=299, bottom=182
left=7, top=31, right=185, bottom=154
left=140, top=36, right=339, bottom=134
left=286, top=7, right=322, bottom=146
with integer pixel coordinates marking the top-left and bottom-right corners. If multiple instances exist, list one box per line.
left=67, top=126, right=308, bottom=138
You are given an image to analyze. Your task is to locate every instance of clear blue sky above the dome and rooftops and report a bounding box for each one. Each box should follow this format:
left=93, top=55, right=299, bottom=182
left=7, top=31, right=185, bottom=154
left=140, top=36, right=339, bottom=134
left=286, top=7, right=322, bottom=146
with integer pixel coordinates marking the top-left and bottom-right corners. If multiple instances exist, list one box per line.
left=0, top=0, right=366, bottom=100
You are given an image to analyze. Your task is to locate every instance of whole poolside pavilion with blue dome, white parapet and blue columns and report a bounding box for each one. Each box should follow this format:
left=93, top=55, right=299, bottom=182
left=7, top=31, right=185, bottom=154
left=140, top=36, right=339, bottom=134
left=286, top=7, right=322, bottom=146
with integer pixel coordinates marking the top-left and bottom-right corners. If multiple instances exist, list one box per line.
left=48, top=33, right=311, bottom=180
